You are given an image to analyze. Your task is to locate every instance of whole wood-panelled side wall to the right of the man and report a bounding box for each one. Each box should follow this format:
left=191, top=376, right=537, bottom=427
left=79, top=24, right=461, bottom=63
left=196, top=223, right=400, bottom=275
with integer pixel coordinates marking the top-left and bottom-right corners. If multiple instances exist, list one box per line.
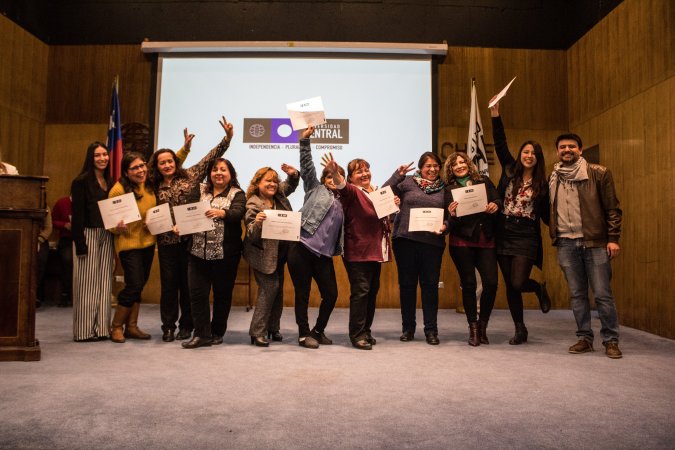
left=568, top=0, right=675, bottom=338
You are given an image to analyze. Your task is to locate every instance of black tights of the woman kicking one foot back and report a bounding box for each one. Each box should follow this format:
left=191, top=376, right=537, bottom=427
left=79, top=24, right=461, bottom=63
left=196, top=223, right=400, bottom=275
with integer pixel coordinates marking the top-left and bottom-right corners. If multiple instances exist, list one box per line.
left=497, top=255, right=539, bottom=323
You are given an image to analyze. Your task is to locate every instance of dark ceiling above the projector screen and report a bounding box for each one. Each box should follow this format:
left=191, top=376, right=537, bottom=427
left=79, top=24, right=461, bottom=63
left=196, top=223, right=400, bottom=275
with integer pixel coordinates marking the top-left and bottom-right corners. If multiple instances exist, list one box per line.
left=0, top=0, right=622, bottom=49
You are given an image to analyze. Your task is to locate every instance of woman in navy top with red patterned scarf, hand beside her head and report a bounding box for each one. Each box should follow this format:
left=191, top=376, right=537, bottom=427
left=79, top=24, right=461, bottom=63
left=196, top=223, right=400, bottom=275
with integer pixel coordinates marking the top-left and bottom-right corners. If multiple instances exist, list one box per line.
left=384, top=152, right=449, bottom=345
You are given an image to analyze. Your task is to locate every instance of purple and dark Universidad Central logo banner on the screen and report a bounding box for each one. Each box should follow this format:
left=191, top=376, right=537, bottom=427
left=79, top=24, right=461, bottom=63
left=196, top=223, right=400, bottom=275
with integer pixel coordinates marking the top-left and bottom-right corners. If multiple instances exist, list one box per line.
left=244, top=118, right=349, bottom=144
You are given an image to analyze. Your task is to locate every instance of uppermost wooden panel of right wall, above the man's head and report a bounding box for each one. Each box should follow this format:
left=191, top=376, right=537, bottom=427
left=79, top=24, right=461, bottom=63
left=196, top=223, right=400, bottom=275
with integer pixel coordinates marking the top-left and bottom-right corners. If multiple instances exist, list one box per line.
left=567, top=0, right=675, bottom=128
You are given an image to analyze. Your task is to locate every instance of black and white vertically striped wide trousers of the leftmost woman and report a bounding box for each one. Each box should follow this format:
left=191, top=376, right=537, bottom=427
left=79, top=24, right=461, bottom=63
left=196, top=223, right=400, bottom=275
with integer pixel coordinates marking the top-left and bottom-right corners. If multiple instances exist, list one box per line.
left=73, top=228, right=115, bottom=341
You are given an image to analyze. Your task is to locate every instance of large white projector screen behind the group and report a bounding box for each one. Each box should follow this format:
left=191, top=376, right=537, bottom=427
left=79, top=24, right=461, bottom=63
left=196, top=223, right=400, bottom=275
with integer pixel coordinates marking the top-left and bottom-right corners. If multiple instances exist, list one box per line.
left=155, top=54, right=432, bottom=210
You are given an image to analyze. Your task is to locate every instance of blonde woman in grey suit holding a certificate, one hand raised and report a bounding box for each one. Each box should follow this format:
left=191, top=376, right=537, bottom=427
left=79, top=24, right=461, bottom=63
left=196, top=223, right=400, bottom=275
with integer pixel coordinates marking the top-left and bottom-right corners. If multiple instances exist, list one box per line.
left=243, top=164, right=300, bottom=347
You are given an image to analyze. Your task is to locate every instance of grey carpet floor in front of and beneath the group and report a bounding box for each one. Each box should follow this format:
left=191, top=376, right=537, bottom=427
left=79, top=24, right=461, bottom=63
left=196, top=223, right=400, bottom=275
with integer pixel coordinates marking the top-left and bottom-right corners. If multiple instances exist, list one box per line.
left=0, top=305, right=675, bottom=449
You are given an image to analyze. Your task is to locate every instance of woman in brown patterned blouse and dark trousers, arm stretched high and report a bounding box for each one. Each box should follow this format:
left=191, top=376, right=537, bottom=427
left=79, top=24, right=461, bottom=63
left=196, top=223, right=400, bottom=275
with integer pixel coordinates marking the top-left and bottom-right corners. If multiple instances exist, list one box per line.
left=150, top=117, right=233, bottom=342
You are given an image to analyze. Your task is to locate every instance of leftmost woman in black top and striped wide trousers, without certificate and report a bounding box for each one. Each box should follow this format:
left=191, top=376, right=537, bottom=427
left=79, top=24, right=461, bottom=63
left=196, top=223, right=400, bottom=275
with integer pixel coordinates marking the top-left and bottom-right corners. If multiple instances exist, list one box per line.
left=70, top=141, right=115, bottom=342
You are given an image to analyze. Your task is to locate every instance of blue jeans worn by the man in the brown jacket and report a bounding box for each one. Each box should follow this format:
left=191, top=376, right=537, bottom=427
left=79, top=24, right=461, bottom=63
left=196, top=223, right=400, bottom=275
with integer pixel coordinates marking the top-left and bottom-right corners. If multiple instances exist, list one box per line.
left=558, top=239, right=619, bottom=342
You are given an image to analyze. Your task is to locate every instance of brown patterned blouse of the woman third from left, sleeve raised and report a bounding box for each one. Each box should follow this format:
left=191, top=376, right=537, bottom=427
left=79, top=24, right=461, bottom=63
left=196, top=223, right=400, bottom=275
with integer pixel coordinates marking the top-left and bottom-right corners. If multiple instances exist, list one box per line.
left=157, top=137, right=230, bottom=245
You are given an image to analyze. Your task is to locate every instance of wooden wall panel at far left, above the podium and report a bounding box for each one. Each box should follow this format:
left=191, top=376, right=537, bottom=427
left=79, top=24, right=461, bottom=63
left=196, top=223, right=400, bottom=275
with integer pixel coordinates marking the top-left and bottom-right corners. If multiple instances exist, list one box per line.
left=0, top=16, right=49, bottom=175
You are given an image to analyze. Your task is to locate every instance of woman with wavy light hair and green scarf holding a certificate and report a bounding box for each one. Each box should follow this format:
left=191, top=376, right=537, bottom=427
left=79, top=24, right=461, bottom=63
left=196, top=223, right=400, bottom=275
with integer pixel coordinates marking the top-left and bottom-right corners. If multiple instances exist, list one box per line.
left=443, top=152, right=502, bottom=347
